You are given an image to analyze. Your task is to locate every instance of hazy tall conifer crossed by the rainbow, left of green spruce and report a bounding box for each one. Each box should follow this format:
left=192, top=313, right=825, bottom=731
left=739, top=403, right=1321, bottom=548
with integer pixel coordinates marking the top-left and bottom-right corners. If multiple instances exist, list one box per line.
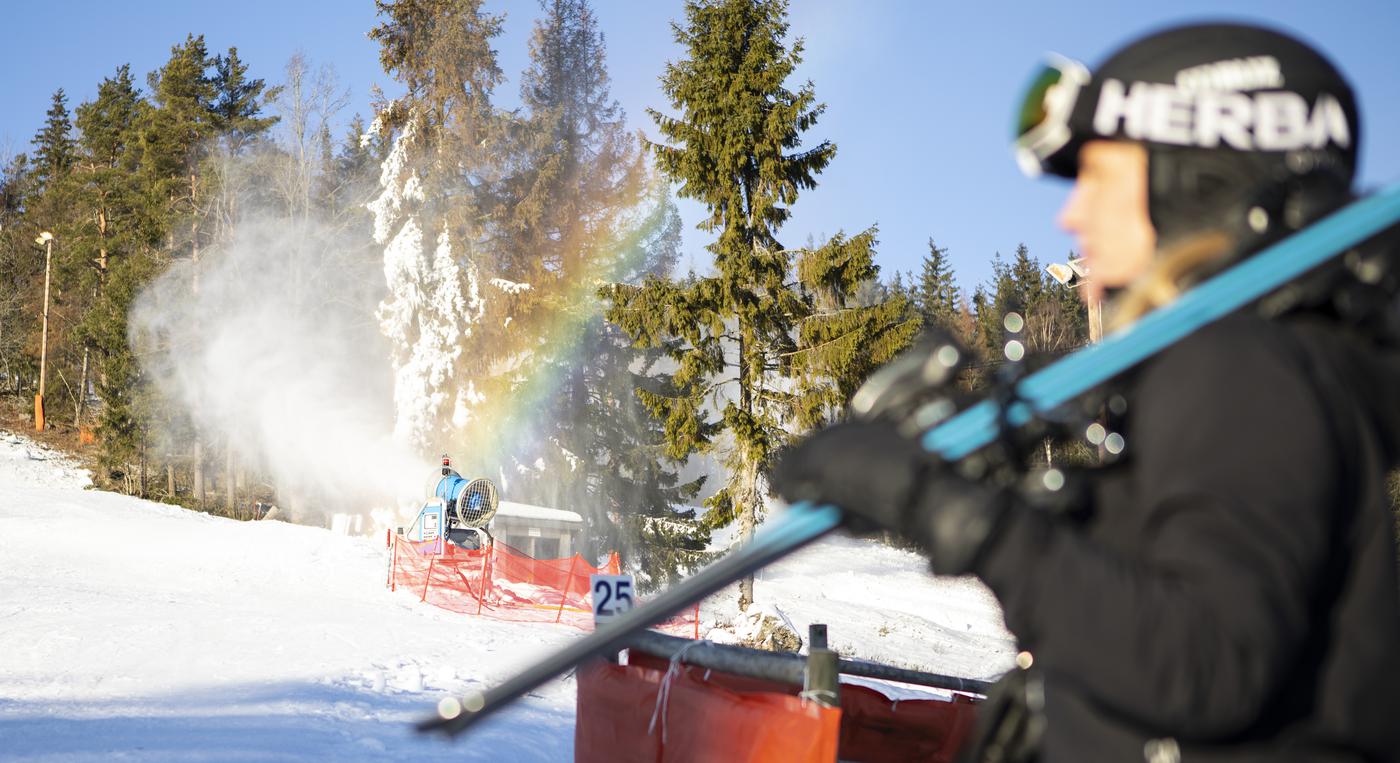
left=497, top=0, right=687, bottom=554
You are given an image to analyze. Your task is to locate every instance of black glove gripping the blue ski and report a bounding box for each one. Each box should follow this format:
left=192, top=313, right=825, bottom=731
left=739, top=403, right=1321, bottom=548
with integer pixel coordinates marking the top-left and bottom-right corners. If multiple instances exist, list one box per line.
left=770, top=421, right=1011, bottom=575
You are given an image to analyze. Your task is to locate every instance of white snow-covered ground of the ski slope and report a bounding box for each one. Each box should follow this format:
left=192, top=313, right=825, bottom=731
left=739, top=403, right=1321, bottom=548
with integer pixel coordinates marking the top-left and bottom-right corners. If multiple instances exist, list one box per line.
left=0, top=433, right=1012, bottom=762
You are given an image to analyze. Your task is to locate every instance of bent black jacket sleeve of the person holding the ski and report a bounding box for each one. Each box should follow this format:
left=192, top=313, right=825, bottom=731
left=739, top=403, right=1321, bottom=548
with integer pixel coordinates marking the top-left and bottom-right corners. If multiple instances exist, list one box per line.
left=979, top=322, right=1340, bottom=741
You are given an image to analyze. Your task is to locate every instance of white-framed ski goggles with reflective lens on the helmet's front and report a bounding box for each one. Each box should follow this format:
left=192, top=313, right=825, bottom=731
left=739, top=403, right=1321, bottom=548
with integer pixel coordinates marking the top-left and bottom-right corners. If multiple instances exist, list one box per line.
left=1015, top=53, right=1091, bottom=178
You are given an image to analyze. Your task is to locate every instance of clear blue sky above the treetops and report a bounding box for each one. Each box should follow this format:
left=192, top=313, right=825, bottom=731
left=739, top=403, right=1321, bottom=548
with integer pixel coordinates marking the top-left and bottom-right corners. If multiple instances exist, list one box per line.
left=0, top=0, right=1400, bottom=288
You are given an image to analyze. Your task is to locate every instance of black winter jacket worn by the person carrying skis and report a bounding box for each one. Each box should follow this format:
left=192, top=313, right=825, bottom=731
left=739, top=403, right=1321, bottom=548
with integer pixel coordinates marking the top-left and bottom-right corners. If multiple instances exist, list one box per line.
left=979, top=315, right=1400, bottom=763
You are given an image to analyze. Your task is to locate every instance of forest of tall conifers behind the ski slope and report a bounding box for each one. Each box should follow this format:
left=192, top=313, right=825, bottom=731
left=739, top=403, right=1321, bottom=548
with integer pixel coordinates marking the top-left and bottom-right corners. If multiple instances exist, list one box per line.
left=0, top=0, right=1089, bottom=582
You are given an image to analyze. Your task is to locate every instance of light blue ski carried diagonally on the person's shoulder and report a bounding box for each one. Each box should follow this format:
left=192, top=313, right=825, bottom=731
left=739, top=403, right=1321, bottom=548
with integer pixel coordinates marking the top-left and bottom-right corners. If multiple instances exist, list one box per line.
left=417, top=183, right=1400, bottom=735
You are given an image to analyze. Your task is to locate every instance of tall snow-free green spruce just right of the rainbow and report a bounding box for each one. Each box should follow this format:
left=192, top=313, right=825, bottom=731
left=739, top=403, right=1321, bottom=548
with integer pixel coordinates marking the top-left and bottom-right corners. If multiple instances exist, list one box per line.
left=609, top=0, right=836, bottom=608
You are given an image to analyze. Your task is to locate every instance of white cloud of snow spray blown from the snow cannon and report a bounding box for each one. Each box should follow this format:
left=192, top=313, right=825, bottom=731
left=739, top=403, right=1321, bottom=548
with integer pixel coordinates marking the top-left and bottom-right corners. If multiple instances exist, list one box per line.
left=130, top=198, right=431, bottom=529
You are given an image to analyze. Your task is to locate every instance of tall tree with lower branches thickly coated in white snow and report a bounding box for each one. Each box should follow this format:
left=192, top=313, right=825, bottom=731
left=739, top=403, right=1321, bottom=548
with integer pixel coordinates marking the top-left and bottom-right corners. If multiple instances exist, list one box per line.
left=370, top=0, right=510, bottom=454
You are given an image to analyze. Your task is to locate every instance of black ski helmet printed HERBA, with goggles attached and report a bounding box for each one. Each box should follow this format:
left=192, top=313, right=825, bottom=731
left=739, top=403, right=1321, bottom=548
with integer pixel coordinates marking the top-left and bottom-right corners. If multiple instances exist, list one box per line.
left=1016, top=24, right=1359, bottom=247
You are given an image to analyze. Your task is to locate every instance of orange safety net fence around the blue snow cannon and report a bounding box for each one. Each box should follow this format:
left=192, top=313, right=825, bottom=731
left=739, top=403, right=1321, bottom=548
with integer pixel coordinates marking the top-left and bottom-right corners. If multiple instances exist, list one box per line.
left=388, top=535, right=700, bottom=638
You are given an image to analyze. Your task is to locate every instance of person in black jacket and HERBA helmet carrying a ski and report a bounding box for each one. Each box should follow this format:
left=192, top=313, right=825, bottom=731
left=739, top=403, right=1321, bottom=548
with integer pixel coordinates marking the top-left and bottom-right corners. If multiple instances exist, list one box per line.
left=773, top=25, right=1400, bottom=763
